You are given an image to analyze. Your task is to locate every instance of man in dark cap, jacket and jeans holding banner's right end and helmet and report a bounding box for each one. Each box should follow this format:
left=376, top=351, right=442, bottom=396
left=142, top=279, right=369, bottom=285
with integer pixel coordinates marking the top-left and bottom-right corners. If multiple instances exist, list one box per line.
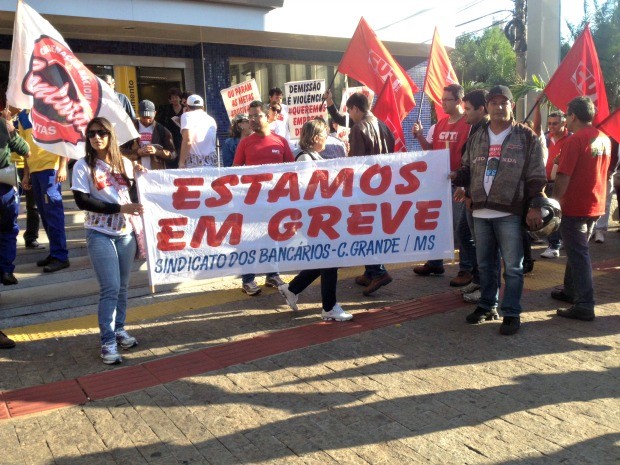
left=449, top=86, right=546, bottom=335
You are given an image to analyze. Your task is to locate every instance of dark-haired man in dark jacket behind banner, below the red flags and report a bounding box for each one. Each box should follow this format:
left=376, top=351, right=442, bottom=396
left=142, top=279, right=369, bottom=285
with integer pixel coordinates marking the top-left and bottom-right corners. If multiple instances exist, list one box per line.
left=347, top=93, right=394, bottom=296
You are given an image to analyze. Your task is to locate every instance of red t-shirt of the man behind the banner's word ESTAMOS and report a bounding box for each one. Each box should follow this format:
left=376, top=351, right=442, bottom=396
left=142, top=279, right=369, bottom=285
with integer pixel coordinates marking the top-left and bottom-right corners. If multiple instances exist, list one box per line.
left=233, top=133, right=295, bottom=166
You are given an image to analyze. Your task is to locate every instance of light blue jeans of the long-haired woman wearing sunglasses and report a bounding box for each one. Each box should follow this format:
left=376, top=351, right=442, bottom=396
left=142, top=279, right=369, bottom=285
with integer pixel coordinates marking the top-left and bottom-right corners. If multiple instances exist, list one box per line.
left=86, top=229, right=136, bottom=345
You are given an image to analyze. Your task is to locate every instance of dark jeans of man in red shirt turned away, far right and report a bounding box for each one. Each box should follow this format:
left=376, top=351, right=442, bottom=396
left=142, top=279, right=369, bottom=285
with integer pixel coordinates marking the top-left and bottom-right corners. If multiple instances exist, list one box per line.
left=560, top=216, right=598, bottom=312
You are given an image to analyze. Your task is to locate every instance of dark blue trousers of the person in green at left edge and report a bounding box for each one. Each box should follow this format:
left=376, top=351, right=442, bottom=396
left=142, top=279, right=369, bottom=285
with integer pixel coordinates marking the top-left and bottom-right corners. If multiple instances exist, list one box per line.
left=0, top=183, right=19, bottom=273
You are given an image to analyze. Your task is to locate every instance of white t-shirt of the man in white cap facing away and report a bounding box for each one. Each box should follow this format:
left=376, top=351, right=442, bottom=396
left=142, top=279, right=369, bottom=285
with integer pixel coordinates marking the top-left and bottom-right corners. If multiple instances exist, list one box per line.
left=181, top=110, right=217, bottom=168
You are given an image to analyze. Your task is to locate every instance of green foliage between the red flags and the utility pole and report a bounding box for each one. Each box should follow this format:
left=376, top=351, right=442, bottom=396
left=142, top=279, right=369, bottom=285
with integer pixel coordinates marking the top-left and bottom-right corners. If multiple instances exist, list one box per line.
left=450, top=27, right=517, bottom=91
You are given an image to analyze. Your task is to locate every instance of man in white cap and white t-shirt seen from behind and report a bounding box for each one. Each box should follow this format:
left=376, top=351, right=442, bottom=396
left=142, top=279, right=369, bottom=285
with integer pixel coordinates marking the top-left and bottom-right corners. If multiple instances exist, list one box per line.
left=179, top=94, right=218, bottom=168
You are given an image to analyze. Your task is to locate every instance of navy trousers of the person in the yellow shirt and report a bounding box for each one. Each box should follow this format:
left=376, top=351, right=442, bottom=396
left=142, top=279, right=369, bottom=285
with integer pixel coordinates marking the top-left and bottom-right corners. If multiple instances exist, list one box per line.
left=30, top=170, right=69, bottom=262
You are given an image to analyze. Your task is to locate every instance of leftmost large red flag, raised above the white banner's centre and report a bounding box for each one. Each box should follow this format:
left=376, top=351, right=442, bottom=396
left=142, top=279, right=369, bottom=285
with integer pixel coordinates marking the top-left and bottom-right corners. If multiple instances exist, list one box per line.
left=338, top=18, right=418, bottom=121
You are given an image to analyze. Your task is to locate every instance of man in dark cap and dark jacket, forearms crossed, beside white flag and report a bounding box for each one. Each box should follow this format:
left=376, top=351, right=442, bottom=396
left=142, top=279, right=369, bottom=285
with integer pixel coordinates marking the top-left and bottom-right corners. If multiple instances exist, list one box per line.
left=121, top=100, right=176, bottom=170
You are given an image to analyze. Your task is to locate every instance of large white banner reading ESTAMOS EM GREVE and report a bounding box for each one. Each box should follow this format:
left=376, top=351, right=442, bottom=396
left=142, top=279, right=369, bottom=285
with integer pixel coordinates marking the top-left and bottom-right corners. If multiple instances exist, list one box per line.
left=138, top=150, right=454, bottom=285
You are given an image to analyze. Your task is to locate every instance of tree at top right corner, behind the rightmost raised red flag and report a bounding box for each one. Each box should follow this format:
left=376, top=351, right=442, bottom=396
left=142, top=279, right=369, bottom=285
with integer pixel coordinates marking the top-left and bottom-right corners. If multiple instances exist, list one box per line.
left=562, top=0, right=620, bottom=109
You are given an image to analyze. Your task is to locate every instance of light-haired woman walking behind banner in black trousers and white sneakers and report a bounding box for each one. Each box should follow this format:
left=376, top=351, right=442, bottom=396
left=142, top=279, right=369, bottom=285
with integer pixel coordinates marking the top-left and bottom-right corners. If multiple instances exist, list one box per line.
left=278, top=118, right=353, bottom=321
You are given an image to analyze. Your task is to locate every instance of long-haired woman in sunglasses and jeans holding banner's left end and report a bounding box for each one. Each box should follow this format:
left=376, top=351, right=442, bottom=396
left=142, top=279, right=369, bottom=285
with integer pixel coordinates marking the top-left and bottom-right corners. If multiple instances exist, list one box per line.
left=71, top=118, right=144, bottom=365
